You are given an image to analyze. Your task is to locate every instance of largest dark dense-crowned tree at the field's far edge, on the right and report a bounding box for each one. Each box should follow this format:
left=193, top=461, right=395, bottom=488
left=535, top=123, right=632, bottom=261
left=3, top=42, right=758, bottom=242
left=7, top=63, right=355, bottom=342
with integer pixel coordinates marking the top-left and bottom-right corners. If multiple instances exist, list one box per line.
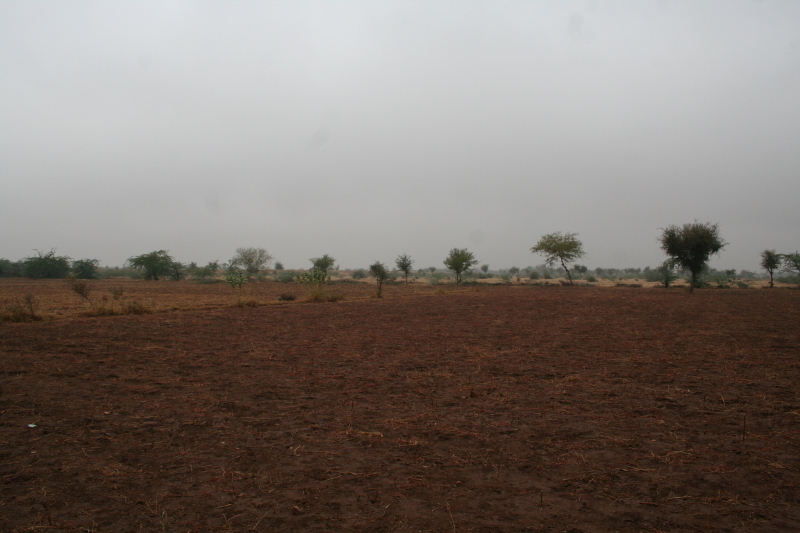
left=658, top=220, right=728, bottom=292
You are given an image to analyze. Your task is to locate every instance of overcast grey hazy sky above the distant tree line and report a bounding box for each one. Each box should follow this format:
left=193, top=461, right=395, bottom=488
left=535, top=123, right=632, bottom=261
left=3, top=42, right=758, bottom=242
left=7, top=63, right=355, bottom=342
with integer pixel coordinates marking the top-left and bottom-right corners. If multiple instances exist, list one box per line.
left=0, top=0, right=800, bottom=270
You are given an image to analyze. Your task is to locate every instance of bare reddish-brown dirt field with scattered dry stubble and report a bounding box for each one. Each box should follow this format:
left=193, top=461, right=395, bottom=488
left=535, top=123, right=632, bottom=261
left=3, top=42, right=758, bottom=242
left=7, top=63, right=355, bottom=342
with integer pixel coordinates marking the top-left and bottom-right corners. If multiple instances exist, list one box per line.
left=0, top=280, right=800, bottom=533
